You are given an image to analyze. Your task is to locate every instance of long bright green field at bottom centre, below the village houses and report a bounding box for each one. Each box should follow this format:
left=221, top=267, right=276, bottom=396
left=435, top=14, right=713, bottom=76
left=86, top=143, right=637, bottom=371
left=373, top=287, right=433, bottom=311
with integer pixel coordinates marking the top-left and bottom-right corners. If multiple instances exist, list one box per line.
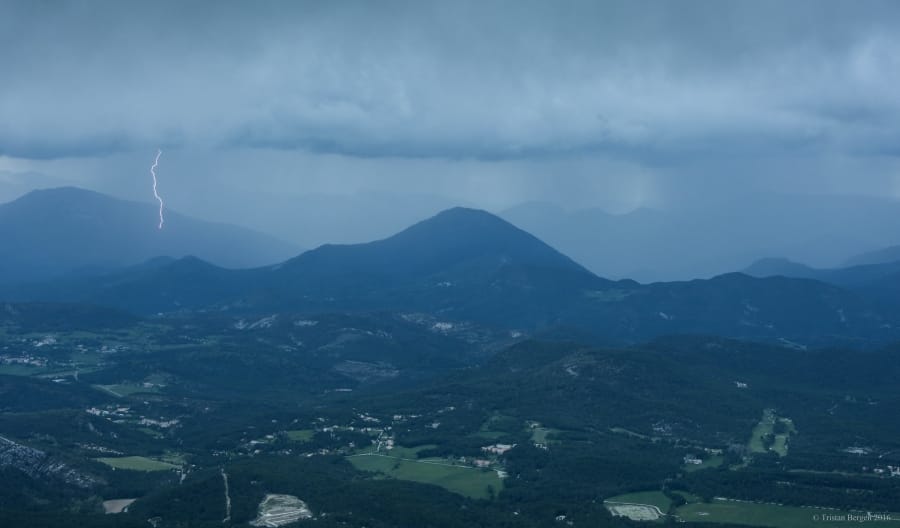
left=348, top=453, right=503, bottom=499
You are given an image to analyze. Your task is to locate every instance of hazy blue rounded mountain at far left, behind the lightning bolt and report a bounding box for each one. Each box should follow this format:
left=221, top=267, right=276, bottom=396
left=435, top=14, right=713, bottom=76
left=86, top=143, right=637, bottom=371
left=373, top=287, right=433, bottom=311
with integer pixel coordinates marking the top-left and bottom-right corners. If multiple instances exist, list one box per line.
left=0, top=187, right=298, bottom=283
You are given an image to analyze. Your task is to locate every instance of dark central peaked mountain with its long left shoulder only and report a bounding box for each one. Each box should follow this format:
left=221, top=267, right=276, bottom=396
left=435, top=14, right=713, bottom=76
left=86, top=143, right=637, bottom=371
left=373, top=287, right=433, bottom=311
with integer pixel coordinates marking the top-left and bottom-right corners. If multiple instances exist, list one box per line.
left=4, top=208, right=612, bottom=326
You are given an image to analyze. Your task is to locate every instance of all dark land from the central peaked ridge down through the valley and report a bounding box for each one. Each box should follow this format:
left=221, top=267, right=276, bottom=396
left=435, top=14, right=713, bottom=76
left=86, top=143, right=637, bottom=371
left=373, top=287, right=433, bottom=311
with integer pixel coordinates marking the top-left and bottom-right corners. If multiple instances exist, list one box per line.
left=0, top=209, right=900, bottom=528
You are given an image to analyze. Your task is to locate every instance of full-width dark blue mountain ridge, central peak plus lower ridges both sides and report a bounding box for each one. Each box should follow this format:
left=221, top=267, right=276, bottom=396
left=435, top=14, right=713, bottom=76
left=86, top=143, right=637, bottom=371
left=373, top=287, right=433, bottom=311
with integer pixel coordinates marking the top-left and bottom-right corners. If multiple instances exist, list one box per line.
left=6, top=208, right=900, bottom=346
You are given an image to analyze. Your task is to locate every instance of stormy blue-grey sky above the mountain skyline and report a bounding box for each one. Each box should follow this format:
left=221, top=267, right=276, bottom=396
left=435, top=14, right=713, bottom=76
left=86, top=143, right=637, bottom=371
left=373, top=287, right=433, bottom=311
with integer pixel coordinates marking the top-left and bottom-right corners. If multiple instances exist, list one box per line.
left=0, top=0, right=900, bottom=255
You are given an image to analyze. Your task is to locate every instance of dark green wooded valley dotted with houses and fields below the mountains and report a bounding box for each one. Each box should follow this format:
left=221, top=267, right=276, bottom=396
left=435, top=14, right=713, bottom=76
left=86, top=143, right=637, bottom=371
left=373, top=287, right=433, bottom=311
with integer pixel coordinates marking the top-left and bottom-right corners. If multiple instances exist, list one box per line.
left=0, top=302, right=900, bottom=528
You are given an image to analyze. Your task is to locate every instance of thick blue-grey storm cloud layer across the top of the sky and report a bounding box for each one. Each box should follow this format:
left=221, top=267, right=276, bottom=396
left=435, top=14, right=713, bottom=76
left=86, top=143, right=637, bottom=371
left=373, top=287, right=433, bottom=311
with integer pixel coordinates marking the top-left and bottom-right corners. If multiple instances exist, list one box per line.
left=0, top=1, right=900, bottom=162
